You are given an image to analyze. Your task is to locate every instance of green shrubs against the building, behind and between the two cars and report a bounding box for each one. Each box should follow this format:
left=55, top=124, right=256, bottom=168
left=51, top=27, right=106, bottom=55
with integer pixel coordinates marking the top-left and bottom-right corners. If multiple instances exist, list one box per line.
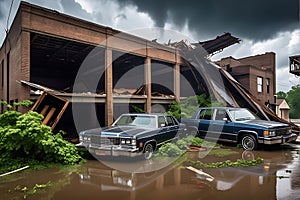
left=167, top=94, right=226, bottom=119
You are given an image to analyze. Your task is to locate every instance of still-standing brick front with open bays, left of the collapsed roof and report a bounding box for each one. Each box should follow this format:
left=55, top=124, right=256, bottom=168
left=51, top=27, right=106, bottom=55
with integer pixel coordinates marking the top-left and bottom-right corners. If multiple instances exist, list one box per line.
left=0, top=2, right=189, bottom=134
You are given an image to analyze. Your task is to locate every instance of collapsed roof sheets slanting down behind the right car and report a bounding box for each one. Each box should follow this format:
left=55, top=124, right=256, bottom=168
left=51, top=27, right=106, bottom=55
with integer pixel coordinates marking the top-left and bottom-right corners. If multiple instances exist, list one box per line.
left=171, top=41, right=300, bottom=134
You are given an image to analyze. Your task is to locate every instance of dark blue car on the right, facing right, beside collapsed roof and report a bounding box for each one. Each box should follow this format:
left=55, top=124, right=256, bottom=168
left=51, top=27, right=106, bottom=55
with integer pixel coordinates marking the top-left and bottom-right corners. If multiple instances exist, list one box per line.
left=181, top=107, right=297, bottom=150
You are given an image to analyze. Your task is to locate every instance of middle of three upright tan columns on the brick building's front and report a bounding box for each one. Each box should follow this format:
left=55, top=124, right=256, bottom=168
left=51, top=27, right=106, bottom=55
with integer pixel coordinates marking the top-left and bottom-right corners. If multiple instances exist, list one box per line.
left=144, top=57, right=151, bottom=113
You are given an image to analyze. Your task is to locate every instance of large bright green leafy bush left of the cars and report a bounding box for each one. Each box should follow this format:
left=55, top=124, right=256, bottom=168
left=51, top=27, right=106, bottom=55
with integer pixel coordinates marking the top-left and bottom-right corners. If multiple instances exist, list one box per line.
left=0, top=101, right=82, bottom=173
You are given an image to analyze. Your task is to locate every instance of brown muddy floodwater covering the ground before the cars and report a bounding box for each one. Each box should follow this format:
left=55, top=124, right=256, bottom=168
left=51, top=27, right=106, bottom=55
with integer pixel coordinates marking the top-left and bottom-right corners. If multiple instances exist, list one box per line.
left=0, top=144, right=300, bottom=200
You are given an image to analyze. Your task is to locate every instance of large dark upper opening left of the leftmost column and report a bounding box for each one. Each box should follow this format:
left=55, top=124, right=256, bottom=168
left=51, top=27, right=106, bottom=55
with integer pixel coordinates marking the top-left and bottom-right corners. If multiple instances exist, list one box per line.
left=30, top=33, right=97, bottom=92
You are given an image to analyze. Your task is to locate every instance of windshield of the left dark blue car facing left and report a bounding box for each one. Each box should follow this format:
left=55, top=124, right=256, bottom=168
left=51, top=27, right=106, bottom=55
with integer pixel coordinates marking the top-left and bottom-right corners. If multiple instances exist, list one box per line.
left=114, top=115, right=156, bottom=128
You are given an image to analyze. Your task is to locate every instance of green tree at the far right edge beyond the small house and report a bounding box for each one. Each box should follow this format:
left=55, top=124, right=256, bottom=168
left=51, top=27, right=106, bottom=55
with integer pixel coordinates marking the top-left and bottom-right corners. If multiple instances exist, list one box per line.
left=286, top=85, right=300, bottom=119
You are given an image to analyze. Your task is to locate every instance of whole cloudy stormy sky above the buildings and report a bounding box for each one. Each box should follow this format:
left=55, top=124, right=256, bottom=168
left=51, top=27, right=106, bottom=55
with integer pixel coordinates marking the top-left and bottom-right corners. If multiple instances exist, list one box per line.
left=0, top=0, right=300, bottom=91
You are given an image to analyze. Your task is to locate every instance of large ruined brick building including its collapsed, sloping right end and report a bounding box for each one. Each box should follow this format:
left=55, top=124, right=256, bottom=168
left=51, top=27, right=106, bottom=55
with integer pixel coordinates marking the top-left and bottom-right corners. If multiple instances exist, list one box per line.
left=0, top=2, right=298, bottom=137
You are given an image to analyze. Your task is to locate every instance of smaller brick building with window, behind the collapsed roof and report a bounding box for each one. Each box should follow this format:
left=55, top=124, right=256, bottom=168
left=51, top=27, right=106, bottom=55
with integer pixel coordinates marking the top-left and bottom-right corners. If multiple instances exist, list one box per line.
left=217, top=52, right=276, bottom=105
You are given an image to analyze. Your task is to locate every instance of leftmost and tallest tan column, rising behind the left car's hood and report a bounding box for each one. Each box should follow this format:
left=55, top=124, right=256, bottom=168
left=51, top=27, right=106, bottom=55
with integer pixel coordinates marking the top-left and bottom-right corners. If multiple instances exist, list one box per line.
left=105, top=47, right=114, bottom=126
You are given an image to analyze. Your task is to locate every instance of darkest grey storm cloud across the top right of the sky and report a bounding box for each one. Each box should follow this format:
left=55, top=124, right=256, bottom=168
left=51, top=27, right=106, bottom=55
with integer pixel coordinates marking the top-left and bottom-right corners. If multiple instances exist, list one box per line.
left=119, top=0, right=300, bottom=40
